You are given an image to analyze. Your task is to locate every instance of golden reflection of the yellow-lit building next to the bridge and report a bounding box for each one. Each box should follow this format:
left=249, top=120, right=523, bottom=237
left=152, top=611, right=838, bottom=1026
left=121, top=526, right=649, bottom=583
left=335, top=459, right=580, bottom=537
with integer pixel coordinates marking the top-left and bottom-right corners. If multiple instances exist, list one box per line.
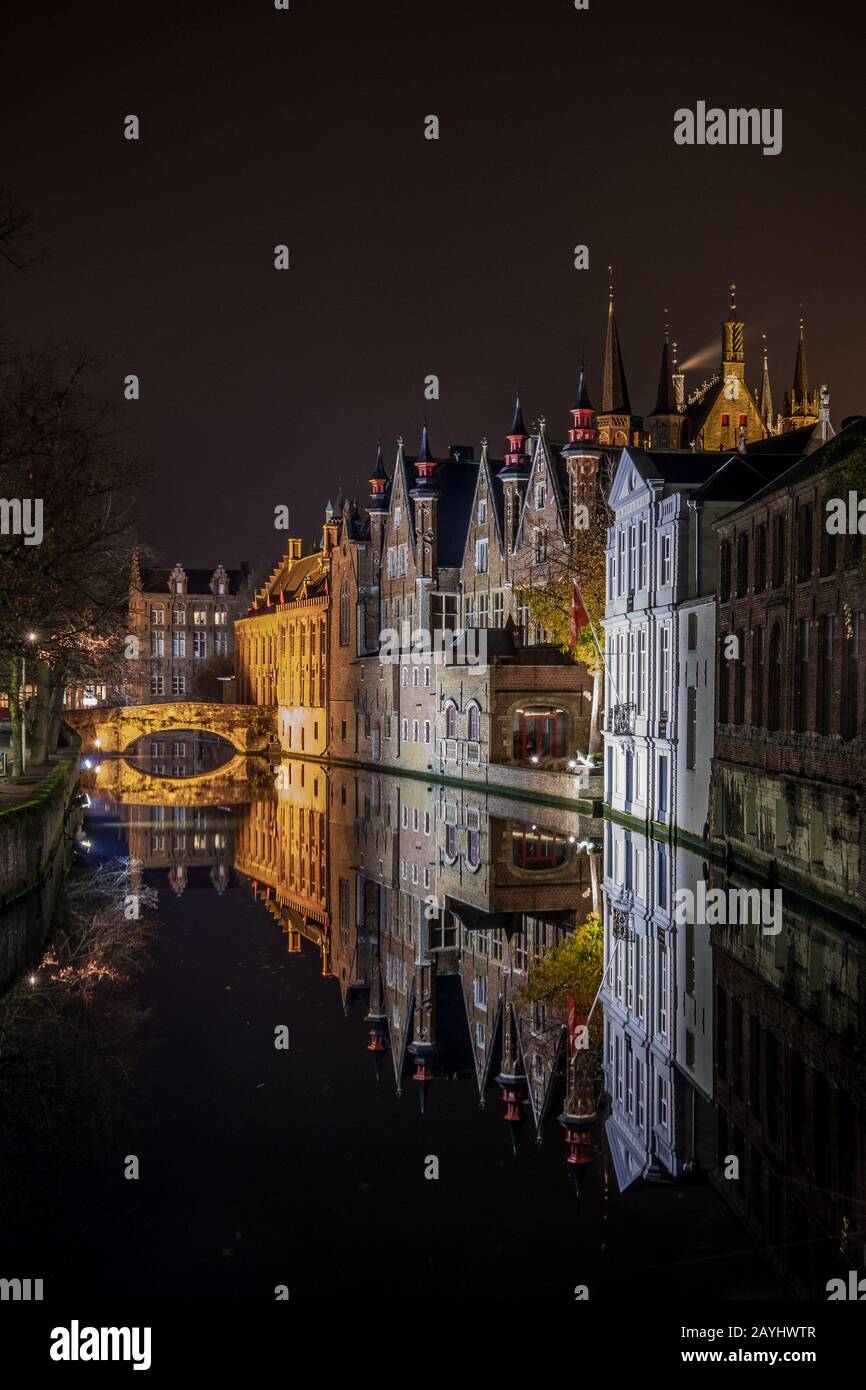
left=235, top=763, right=331, bottom=974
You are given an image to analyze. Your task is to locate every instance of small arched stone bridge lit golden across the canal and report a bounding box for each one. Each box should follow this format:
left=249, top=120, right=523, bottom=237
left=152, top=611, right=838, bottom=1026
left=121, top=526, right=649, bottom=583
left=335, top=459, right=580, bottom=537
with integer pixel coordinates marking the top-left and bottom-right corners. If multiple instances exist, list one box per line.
left=64, top=701, right=279, bottom=755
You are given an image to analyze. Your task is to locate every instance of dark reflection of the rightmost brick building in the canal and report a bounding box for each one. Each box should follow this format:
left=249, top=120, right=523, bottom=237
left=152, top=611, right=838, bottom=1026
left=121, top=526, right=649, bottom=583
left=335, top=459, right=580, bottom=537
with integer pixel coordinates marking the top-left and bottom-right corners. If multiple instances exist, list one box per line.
left=712, top=878, right=866, bottom=1298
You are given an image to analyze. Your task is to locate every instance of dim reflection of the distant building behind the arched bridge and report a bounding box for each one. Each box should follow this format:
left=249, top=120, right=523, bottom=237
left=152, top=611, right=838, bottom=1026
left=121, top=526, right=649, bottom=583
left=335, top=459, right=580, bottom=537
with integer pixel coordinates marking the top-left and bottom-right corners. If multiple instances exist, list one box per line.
left=118, top=805, right=234, bottom=897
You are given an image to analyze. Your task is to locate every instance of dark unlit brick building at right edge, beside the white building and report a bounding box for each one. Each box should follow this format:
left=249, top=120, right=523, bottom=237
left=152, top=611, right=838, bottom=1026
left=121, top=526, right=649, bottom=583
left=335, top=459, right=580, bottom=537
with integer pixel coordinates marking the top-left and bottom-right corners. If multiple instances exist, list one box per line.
left=712, top=411, right=866, bottom=912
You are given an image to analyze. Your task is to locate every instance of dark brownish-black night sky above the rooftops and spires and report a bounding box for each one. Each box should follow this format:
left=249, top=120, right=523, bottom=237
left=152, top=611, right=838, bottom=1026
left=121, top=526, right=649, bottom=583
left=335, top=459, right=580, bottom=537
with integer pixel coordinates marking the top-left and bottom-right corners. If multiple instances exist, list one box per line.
left=0, top=0, right=866, bottom=566
